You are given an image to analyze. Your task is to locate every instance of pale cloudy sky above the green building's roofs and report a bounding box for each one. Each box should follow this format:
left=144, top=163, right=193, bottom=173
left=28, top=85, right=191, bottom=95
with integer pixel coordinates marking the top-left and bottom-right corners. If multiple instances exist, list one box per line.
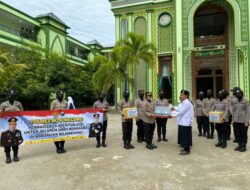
left=3, top=0, right=115, bottom=47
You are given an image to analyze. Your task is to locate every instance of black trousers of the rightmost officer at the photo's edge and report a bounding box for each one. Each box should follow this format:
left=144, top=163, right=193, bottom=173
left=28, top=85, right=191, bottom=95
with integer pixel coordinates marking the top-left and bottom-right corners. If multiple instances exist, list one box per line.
left=234, top=122, right=248, bottom=146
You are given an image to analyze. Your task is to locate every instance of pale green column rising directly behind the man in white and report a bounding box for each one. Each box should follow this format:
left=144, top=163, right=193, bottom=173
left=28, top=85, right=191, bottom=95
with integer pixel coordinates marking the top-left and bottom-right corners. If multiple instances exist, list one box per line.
left=174, top=1, right=184, bottom=102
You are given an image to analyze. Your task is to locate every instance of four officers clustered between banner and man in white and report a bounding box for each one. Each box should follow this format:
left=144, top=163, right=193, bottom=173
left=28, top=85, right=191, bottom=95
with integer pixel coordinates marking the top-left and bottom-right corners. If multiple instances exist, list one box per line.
left=118, top=90, right=172, bottom=150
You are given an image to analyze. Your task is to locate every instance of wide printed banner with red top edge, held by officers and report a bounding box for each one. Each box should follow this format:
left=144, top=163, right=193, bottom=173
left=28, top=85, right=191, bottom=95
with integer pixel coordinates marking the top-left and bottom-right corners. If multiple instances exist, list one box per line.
left=0, top=109, right=103, bottom=144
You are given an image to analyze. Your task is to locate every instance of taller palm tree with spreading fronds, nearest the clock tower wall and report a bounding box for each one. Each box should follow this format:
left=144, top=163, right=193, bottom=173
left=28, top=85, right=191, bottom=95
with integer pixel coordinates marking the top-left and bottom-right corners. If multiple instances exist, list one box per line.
left=116, top=33, right=156, bottom=95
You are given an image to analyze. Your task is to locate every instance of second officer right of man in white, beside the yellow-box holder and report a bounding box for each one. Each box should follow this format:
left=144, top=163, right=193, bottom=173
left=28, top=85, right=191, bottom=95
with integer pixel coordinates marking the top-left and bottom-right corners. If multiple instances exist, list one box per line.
left=203, top=89, right=215, bottom=139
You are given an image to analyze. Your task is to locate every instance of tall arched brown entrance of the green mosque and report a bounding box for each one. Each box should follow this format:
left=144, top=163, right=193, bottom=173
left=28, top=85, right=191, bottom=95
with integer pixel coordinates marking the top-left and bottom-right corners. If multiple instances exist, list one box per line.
left=192, top=3, right=229, bottom=99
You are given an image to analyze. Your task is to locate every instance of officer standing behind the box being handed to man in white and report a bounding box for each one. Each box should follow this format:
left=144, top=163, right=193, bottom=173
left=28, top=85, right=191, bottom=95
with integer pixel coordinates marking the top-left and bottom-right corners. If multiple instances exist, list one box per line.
left=156, top=91, right=169, bottom=142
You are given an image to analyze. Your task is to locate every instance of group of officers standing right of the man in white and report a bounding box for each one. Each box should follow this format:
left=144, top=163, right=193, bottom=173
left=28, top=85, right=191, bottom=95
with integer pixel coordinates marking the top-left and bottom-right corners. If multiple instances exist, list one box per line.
left=195, top=87, right=249, bottom=152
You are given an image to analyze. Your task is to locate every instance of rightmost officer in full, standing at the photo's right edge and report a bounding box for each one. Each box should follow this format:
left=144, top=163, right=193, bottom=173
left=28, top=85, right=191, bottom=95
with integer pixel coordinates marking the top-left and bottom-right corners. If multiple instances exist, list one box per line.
left=232, top=90, right=249, bottom=152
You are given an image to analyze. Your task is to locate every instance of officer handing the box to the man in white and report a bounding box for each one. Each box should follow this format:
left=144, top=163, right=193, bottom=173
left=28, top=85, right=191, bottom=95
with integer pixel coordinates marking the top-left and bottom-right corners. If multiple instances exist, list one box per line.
left=142, top=92, right=157, bottom=150
